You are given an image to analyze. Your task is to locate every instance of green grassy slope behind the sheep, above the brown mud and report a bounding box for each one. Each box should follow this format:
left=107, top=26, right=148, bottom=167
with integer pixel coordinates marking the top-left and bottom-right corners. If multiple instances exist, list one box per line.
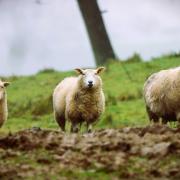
left=1, top=56, right=180, bottom=132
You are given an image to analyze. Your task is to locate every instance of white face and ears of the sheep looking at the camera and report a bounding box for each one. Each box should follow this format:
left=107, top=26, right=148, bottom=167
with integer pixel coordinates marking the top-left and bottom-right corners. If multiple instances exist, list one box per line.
left=75, top=67, right=105, bottom=90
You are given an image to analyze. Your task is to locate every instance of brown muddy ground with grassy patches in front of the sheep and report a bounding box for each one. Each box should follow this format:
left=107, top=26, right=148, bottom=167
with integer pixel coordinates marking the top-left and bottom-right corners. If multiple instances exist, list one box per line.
left=0, top=126, right=180, bottom=180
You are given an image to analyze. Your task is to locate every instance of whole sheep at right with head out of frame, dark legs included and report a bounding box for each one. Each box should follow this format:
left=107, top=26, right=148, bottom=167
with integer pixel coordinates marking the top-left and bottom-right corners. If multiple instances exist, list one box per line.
left=144, top=67, right=180, bottom=126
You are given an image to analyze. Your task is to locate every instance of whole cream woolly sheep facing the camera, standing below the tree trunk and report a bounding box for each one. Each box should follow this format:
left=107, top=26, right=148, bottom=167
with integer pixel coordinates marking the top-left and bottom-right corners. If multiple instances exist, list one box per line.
left=53, top=67, right=105, bottom=133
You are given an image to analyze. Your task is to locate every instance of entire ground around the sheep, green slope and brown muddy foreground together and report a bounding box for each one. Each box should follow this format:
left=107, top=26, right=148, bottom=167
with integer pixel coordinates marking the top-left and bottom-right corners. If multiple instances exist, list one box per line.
left=0, top=56, right=180, bottom=180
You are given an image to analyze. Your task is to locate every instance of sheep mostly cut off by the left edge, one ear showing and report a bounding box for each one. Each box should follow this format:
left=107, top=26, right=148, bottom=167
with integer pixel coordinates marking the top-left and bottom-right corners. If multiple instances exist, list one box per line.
left=0, top=80, right=10, bottom=127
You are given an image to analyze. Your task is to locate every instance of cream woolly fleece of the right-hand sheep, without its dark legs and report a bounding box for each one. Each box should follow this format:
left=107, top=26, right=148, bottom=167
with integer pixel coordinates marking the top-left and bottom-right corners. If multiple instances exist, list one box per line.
left=144, top=68, right=180, bottom=114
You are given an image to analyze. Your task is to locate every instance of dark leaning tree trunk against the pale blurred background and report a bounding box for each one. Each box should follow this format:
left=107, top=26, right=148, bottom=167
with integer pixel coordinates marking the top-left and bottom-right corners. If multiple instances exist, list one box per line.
left=77, top=0, right=115, bottom=65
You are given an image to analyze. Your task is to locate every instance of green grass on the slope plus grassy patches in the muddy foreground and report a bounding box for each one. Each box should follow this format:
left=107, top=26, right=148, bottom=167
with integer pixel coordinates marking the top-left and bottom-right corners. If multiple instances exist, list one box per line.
left=0, top=56, right=180, bottom=179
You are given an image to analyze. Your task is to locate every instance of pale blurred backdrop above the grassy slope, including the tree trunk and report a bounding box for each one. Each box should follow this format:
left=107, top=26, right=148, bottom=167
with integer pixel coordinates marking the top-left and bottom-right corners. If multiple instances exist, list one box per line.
left=0, top=0, right=180, bottom=76
